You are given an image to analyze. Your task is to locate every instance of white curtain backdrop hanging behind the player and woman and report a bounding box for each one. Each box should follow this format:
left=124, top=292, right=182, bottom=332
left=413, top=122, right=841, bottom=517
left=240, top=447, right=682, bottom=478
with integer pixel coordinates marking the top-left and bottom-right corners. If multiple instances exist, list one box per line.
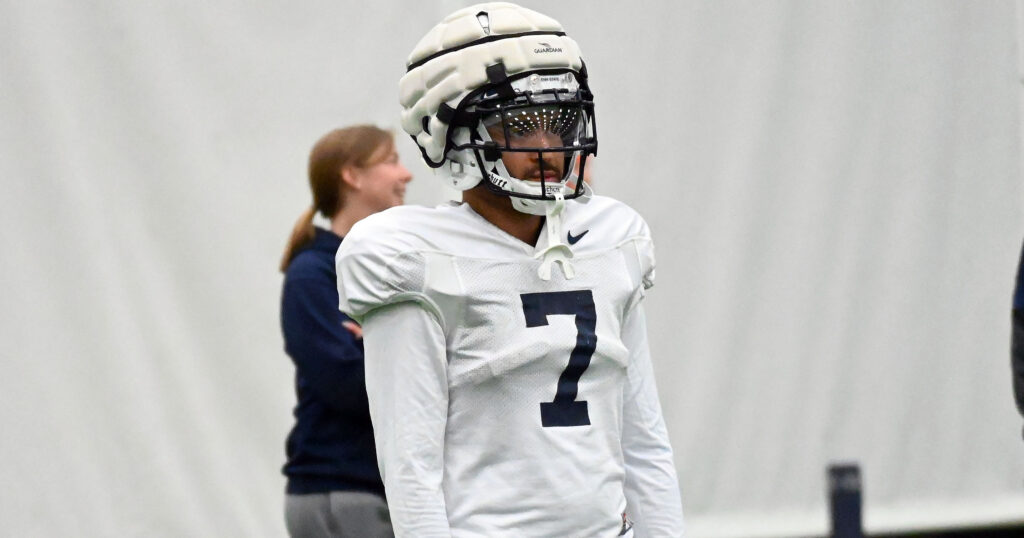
left=0, top=0, right=1024, bottom=537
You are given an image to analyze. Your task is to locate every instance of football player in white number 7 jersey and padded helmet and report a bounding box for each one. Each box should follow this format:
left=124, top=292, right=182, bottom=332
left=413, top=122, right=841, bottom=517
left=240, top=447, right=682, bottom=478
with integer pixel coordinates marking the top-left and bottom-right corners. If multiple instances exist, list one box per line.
left=336, top=3, right=683, bottom=538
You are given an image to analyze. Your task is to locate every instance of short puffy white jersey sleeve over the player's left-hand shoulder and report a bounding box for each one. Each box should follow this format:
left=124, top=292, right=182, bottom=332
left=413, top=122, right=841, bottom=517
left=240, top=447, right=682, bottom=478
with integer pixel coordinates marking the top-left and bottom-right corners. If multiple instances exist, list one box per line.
left=335, top=215, right=443, bottom=324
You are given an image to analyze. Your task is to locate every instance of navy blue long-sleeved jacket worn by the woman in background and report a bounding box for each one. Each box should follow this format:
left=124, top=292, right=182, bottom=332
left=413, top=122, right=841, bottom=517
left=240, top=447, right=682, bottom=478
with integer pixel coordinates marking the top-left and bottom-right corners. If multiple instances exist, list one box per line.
left=281, top=229, right=384, bottom=496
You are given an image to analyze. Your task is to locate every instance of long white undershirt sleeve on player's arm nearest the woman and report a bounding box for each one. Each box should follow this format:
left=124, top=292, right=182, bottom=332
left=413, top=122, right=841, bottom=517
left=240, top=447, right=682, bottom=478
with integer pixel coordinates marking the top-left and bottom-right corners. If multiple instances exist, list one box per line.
left=362, top=302, right=452, bottom=538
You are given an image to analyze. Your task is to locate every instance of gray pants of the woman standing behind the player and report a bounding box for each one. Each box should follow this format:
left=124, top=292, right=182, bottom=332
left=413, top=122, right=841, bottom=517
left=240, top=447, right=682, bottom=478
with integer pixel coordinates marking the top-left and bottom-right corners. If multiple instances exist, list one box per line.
left=285, top=491, right=394, bottom=538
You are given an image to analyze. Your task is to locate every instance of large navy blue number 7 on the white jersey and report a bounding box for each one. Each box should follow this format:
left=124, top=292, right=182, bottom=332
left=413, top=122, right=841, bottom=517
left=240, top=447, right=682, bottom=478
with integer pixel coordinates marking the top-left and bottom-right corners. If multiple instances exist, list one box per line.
left=520, top=290, right=597, bottom=427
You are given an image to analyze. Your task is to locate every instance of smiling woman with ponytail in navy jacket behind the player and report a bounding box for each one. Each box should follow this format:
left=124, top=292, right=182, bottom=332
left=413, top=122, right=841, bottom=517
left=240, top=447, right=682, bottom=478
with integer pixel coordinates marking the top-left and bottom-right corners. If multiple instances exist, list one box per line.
left=281, top=125, right=413, bottom=538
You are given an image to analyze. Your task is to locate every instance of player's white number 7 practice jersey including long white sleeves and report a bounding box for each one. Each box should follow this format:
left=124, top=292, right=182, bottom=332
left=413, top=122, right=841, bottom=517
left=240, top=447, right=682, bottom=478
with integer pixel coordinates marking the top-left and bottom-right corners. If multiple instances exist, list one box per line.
left=337, top=197, right=682, bottom=538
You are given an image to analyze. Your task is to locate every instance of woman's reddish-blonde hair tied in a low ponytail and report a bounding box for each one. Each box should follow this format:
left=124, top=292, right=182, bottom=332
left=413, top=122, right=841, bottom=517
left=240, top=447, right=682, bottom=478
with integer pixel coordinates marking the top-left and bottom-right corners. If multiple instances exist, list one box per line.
left=280, top=125, right=394, bottom=273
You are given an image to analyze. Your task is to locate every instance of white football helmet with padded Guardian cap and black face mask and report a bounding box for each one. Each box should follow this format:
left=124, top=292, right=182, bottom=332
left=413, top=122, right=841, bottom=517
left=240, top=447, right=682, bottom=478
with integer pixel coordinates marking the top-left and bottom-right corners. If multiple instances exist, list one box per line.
left=399, top=2, right=597, bottom=215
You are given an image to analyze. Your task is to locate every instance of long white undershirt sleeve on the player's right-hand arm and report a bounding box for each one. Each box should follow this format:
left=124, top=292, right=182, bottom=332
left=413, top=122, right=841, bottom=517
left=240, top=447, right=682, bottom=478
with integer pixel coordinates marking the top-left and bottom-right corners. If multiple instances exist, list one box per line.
left=622, top=304, right=683, bottom=538
